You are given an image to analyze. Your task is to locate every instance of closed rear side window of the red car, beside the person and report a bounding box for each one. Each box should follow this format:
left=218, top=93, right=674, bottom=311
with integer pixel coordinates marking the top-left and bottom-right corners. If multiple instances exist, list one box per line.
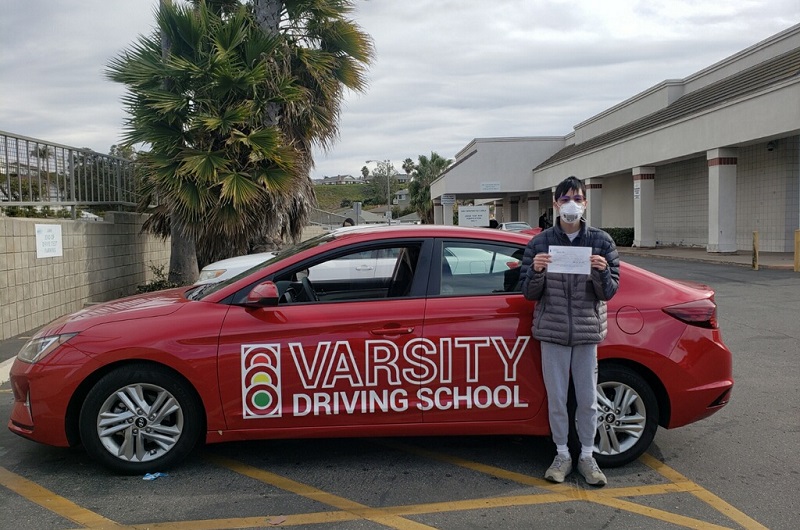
left=439, top=241, right=524, bottom=296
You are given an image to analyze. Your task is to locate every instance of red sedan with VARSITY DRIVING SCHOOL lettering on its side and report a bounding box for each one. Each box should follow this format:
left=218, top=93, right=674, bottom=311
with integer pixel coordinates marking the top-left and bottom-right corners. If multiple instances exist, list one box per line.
left=8, top=225, right=733, bottom=473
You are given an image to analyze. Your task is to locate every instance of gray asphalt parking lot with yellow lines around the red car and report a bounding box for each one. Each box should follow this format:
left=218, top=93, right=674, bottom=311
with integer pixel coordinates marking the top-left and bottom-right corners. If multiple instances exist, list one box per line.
left=0, top=256, right=800, bottom=529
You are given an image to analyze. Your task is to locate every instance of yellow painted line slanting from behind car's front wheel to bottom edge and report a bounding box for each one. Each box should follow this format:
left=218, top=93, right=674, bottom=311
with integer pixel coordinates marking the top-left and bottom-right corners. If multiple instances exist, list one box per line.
left=206, top=455, right=432, bottom=530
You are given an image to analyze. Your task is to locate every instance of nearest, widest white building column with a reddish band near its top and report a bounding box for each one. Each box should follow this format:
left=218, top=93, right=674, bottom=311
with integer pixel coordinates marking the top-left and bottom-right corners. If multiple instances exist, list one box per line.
left=706, top=148, right=738, bottom=252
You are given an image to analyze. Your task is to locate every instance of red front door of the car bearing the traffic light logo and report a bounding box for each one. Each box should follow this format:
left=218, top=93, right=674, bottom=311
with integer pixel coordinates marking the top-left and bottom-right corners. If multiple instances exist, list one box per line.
left=219, top=242, right=425, bottom=429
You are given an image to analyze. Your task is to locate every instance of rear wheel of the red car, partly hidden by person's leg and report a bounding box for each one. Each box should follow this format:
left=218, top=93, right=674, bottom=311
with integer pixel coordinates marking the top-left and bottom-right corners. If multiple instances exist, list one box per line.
left=594, top=365, right=659, bottom=467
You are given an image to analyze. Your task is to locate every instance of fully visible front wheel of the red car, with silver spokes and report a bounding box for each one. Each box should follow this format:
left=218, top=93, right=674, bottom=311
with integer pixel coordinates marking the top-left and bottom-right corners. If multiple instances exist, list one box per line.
left=79, top=364, right=203, bottom=475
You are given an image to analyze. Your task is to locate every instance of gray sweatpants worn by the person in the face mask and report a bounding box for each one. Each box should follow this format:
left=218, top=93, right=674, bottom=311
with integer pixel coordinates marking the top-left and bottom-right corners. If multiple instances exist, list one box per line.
left=541, top=342, right=597, bottom=447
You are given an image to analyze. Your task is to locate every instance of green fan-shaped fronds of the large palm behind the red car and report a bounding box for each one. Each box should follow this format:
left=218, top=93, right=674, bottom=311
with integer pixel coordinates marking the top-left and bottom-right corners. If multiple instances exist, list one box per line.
left=108, top=0, right=371, bottom=276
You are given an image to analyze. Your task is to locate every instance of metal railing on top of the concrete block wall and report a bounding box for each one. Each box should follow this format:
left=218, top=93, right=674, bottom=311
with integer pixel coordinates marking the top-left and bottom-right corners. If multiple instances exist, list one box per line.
left=0, top=131, right=137, bottom=217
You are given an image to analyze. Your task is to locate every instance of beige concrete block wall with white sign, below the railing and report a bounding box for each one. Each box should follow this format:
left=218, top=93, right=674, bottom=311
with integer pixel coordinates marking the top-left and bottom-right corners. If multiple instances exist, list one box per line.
left=0, top=212, right=170, bottom=340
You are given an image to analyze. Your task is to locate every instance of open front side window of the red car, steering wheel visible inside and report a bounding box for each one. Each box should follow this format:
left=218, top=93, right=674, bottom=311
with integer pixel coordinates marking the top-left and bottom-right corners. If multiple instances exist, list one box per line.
left=275, top=245, right=419, bottom=304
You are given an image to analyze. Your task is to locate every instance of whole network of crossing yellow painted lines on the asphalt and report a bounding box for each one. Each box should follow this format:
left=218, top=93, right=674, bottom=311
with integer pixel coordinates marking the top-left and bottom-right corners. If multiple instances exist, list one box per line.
left=0, top=446, right=766, bottom=530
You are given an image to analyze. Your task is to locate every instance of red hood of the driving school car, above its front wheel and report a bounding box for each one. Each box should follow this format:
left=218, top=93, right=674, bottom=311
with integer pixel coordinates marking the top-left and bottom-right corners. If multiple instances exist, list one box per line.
left=42, top=287, right=188, bottom=334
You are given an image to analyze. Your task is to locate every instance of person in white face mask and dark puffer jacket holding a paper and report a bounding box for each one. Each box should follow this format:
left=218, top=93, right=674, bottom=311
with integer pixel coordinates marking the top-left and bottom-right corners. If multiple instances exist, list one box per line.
left=521, top=177, right=619, bottom=486
